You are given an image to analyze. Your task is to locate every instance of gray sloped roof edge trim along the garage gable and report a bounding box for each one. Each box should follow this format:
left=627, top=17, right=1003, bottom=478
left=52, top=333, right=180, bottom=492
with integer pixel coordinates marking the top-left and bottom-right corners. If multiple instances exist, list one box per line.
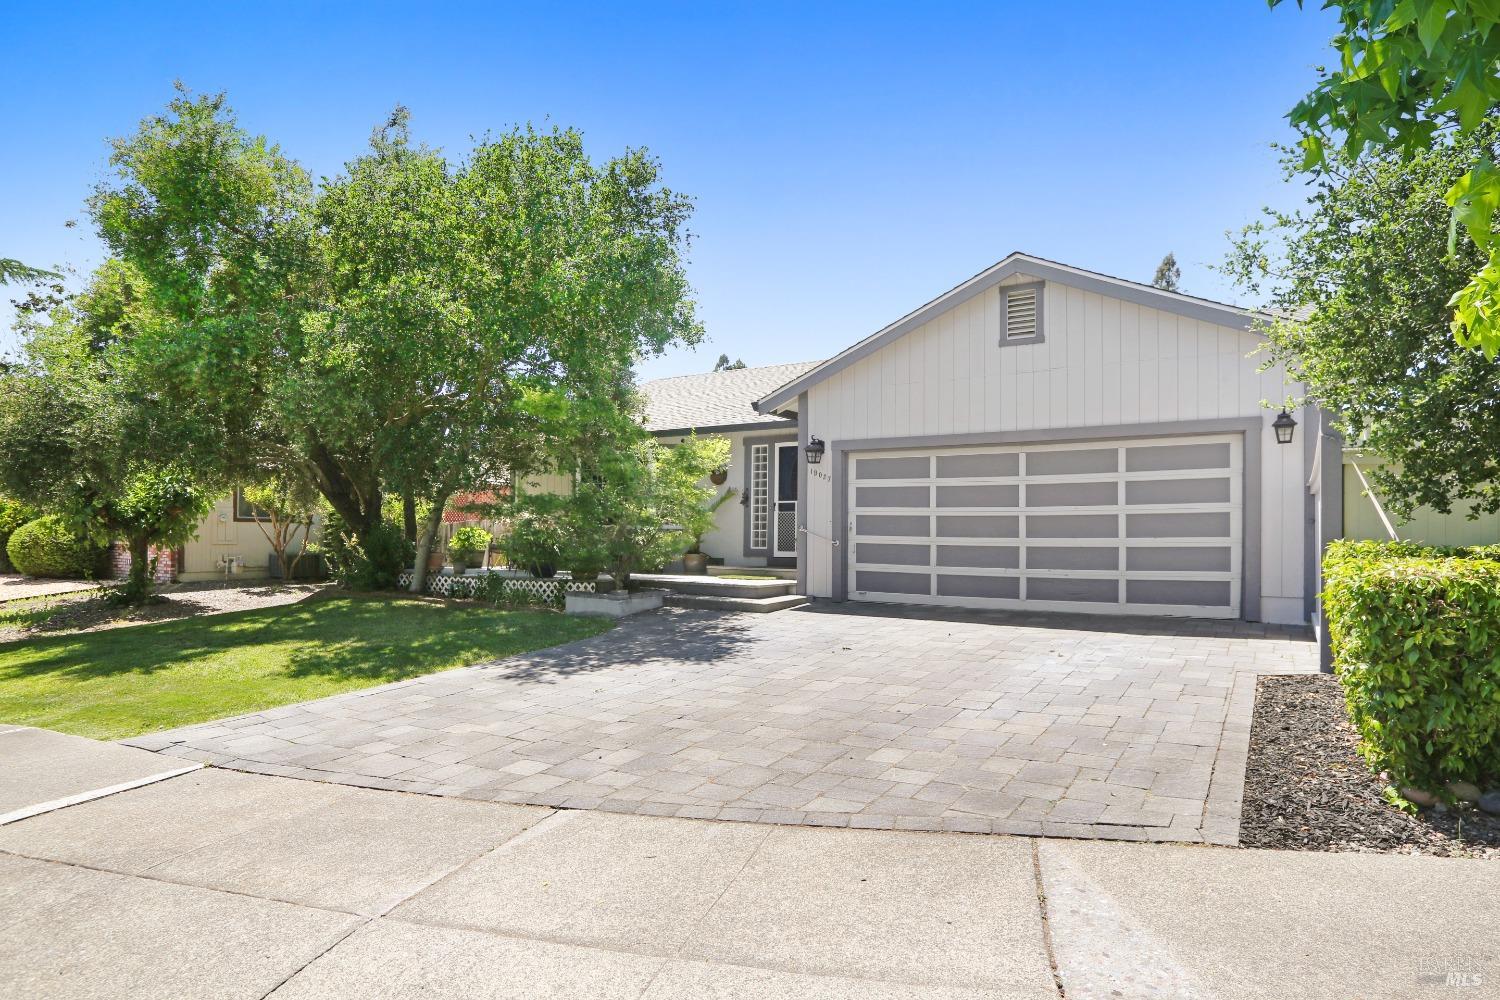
left=756, top=252, right=1271, bottom=414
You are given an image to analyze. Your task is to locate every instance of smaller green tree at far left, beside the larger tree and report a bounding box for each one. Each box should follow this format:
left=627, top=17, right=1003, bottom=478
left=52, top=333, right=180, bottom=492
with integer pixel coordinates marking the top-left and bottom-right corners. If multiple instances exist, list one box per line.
left=0, top=262, right=216, bottom=603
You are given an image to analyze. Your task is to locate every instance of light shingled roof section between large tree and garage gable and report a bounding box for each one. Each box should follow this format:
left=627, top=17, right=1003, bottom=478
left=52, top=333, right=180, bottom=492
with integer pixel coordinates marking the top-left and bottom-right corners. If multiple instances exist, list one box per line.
left=641, top=361, right=818, bottom=435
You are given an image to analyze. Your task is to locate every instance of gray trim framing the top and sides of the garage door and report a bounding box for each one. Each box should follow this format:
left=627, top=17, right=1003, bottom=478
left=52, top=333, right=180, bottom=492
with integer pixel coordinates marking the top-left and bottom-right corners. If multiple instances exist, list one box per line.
left=828, top=417, right=1265, bottom=622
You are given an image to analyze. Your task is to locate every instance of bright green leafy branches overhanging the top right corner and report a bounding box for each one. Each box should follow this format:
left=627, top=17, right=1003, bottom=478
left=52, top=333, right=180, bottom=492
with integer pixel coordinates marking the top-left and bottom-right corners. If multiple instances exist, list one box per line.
left=1269, top=0, right=1500, bottom=360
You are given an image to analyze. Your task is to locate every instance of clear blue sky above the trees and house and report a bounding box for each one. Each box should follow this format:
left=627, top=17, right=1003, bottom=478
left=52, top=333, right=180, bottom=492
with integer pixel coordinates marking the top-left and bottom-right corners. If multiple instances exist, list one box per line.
left=0, top=0, right=1334, bottom=378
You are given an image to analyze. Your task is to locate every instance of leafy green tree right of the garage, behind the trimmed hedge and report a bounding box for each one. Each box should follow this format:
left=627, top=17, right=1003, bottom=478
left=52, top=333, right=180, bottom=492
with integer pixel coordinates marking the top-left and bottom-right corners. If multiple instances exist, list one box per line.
left=1229, top=127, right=1500, bottom=517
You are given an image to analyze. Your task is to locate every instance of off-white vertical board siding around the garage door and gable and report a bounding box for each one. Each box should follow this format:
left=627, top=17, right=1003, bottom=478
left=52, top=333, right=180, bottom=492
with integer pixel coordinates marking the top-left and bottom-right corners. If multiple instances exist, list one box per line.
left=800, top=274, right=1308, bottom=624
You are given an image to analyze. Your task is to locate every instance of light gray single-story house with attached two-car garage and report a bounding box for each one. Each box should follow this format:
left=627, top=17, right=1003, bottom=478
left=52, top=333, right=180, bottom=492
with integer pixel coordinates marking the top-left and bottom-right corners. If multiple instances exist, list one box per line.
left=642, top=253, right=1343, bottom=622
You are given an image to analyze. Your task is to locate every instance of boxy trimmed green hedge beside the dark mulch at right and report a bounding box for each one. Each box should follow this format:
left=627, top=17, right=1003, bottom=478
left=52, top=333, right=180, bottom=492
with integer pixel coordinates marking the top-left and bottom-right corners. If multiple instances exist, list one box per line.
left=1323, top=543, right=1500, bottom=789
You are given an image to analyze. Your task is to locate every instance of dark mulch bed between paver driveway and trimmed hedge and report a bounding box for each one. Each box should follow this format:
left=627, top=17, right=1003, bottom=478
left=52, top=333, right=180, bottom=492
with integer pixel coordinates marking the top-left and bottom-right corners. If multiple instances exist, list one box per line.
left=1239, top=675, right=1500, bottom=859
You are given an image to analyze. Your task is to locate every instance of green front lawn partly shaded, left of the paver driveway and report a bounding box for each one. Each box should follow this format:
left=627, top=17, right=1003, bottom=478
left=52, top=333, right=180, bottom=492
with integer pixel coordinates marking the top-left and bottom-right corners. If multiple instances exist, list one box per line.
left=0, top=595, right=609, bottom=739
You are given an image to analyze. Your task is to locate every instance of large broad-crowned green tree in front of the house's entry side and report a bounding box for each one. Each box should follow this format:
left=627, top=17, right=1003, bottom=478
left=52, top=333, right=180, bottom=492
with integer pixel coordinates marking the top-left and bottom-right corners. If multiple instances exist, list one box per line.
left=92, top=93, right=701, bottom=589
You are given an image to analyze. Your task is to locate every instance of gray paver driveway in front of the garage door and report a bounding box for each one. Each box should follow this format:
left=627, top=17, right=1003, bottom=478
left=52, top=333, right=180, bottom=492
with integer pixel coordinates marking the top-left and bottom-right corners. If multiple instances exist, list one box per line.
left=131, top=606, right=1317, bottom=843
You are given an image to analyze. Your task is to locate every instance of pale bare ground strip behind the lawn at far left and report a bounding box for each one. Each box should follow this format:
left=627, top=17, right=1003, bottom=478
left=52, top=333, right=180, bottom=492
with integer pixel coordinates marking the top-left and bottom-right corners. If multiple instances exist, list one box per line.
left=0, top=583, right=329, bottom=642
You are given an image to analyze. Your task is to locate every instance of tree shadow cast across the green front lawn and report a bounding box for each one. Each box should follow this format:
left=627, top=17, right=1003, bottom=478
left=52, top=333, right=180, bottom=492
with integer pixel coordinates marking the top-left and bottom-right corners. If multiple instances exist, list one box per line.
left=0, top=594, right=587, bottom=681
